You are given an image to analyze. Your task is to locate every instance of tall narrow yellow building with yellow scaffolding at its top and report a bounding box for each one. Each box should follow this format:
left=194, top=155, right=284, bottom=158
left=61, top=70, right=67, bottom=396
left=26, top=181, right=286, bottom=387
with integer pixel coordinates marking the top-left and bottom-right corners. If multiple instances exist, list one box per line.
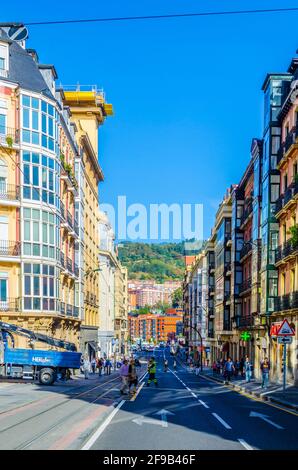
left=64, top=87, right=112, bottom=357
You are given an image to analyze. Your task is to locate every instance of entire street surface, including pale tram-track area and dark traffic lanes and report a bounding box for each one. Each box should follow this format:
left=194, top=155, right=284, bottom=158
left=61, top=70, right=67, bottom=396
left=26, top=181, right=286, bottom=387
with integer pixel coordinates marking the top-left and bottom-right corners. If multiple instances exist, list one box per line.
left=0, top=351, right=298, bottom=450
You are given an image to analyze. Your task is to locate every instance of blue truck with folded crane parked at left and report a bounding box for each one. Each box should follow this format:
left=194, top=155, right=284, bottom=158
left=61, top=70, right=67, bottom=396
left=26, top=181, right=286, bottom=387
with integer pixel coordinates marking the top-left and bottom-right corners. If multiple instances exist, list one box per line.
left=0, top=321, right=81, bottom=385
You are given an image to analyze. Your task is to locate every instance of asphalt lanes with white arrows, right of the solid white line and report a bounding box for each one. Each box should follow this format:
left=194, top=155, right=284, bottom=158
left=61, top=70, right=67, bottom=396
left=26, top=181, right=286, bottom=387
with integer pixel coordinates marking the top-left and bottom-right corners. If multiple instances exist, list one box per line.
left=85, top=352, right=298, bottom=450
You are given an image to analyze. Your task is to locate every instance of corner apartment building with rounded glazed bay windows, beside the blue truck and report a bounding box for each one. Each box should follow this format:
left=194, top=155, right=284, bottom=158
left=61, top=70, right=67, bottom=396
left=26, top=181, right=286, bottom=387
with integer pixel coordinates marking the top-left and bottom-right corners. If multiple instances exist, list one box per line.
left=0, top=28, right=83, bottom=348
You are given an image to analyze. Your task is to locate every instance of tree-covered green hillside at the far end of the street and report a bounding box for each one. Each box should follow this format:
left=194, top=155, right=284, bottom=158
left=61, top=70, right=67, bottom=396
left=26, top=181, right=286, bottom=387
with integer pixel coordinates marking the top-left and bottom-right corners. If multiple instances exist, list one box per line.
left=118, top=242, right=184, bottom=282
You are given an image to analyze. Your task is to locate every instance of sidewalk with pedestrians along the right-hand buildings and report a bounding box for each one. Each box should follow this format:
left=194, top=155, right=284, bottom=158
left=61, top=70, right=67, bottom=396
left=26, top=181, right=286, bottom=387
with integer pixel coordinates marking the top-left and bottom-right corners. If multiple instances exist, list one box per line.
left=200, top=368, right=298, bottom=411
